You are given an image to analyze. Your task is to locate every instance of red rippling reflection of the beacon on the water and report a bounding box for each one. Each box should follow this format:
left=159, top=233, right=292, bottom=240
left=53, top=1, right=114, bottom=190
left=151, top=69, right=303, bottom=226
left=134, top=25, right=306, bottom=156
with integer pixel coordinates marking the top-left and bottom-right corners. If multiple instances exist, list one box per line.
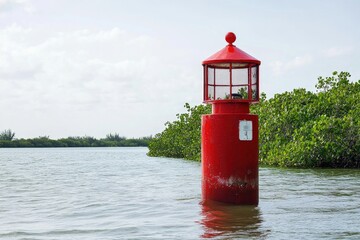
left=200, top=201, right=264, bottom=239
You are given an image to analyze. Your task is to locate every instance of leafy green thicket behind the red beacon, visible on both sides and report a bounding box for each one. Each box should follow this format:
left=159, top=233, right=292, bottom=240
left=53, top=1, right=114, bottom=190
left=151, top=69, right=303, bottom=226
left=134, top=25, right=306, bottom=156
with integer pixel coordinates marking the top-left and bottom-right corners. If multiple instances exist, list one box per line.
left=148, top=71, right=360, bottom=168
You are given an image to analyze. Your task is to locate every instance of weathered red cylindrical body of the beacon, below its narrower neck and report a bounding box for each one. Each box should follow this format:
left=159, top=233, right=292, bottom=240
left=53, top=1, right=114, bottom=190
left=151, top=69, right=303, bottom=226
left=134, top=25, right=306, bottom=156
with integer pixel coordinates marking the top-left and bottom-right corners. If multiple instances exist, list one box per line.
left=201, top=113, right=259, bottom=205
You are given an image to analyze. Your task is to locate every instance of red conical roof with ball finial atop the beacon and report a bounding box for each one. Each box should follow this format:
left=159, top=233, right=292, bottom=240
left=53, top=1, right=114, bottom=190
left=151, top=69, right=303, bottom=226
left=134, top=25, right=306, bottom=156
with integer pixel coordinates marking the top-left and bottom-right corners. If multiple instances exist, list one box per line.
left=203, top=32, right=260, bottom=65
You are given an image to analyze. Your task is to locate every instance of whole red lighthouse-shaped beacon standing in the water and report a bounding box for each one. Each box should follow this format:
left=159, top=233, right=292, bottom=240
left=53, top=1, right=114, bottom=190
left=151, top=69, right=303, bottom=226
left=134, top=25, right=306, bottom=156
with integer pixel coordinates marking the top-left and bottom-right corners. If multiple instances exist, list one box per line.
left=201, top=32, right=260, bottom=205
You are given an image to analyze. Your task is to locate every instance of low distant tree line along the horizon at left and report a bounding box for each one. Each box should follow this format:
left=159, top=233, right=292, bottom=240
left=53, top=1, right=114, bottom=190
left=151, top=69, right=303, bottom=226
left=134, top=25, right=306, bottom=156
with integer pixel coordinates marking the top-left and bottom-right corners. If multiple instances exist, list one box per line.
left=0, top=129, right=152, bottom=148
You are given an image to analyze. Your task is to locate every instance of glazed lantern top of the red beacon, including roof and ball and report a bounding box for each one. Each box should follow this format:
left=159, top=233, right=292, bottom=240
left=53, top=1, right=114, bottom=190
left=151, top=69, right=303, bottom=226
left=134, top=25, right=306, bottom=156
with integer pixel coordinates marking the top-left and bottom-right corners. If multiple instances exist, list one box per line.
left=202, top=32, right=260, bottom=103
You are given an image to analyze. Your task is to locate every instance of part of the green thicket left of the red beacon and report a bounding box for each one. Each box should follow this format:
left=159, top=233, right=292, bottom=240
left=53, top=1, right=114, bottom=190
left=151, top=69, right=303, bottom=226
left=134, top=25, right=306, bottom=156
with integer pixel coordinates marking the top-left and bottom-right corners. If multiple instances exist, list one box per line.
left=148, top=103, right=211, bottom=161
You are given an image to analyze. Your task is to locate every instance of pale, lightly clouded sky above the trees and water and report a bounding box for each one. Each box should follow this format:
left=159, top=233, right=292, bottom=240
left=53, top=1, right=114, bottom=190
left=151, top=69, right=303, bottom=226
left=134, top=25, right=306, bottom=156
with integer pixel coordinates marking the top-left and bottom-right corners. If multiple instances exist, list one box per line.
left=0, top=0, right=360, bottom=139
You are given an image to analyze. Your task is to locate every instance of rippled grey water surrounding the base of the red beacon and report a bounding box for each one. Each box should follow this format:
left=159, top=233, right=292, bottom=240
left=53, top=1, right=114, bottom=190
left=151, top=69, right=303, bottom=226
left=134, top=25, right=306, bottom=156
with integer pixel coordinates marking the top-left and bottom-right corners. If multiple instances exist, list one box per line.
left=0, top=148, right=360, bottom=240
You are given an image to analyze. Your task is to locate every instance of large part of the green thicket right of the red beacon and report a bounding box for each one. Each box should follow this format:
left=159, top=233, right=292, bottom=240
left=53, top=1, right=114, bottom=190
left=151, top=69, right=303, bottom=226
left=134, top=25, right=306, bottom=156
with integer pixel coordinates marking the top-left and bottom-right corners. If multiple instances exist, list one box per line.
left=253, top=72, right=360, bottom=168
